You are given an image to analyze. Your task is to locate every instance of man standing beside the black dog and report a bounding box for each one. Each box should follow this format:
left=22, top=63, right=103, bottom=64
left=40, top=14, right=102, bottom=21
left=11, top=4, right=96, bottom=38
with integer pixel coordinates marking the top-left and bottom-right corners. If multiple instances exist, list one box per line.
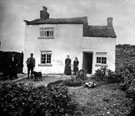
left=26, top=53, right=35, bottom=79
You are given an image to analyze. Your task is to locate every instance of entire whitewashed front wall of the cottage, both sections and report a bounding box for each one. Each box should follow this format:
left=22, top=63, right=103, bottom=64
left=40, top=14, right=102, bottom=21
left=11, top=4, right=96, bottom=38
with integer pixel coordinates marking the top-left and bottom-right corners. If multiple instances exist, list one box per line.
left=24, top=24, right=116, bottom=73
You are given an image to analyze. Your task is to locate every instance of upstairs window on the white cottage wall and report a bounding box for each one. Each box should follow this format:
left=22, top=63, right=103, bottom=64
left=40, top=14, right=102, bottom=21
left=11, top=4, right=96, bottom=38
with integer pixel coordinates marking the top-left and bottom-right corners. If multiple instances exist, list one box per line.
left=40, top=27, right=54, bottom=39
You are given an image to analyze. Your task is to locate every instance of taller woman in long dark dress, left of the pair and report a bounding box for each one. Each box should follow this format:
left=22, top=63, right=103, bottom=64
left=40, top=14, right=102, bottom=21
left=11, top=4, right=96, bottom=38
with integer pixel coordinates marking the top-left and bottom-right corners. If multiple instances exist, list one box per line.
left=64, top=55, right=71, bottom=75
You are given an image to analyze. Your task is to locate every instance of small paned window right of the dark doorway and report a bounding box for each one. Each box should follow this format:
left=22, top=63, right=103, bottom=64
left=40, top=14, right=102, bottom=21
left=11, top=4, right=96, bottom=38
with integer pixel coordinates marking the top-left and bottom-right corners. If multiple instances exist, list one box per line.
left=96, top=52, right=107, bottom=65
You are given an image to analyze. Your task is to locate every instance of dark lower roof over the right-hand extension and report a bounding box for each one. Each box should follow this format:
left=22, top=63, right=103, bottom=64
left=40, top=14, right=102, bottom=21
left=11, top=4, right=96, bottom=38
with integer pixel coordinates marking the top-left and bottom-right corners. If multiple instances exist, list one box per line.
left=84, top=25, right=116, bottom=38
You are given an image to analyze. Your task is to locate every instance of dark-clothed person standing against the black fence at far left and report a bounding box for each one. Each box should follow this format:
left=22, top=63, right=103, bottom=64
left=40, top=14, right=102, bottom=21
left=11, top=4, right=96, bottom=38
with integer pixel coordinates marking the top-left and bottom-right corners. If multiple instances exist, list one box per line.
left=9, top=54, right=18, bottom=80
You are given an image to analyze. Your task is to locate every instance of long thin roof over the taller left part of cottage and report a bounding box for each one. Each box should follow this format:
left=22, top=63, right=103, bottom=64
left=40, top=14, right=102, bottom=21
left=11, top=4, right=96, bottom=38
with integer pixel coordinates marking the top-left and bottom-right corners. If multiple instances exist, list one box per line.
left=24, top=17, right=88, bottom=25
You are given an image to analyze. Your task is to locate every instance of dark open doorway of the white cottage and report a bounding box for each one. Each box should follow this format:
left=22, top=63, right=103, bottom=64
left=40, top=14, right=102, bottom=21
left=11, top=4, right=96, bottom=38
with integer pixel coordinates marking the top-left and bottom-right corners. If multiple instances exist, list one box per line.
left=83, top=52, right=93, bottom=74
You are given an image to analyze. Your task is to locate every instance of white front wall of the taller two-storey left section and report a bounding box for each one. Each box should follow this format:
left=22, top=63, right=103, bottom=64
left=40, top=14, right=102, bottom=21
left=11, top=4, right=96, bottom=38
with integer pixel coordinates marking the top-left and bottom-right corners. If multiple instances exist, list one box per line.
left=24, top=24, right=83, bottom=73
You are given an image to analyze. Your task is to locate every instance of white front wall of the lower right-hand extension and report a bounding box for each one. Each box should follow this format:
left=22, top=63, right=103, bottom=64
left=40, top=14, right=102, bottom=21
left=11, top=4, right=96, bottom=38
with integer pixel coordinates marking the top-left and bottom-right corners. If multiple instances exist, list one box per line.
left=83, top=37, right=116, bottom=73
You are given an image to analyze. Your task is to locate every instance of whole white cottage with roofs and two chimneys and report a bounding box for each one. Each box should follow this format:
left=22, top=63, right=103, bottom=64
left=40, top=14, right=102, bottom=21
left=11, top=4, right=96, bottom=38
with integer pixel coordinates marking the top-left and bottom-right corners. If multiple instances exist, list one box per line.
left=24, top=7, right=116, bottom=74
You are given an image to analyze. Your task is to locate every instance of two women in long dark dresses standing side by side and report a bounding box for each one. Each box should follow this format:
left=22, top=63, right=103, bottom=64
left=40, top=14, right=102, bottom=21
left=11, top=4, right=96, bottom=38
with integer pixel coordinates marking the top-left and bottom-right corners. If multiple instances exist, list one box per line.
left=64, top=55, right=79, bottom=75
